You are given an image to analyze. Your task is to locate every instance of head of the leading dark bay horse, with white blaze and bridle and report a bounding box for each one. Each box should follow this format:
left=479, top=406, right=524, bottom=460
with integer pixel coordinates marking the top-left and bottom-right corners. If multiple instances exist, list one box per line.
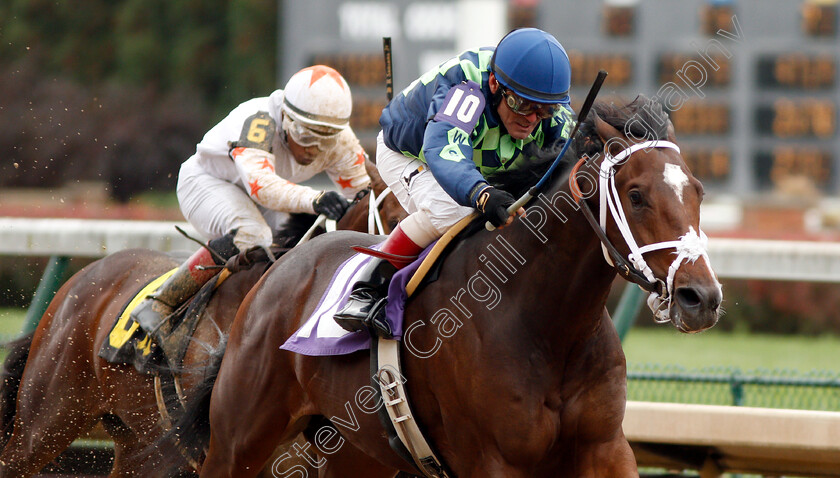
left=572, top=96, right=723, bottom=333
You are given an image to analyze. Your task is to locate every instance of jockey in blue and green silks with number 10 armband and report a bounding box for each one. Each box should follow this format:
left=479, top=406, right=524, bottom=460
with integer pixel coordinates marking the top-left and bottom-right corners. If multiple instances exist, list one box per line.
left=335, top=28, right=572, bottom=336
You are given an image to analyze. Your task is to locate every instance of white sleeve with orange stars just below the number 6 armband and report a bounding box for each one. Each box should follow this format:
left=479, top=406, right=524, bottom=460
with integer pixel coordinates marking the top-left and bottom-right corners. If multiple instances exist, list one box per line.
left=230, top=148, right=321, bottom=214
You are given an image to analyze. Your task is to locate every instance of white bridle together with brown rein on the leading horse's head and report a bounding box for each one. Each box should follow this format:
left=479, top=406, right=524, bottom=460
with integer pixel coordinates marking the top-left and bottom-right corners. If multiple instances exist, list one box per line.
left=569, top=140, right=711, bottom=323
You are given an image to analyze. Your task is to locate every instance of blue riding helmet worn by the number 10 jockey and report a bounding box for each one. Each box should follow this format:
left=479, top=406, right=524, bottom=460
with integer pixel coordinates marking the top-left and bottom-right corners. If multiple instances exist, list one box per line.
left=490, top=28, right=572, bottom=104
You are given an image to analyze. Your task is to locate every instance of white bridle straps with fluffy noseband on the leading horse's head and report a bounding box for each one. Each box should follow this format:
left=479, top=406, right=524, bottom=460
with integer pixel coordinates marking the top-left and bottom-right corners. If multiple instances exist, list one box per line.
left=599, top=140, right=720, bottom=323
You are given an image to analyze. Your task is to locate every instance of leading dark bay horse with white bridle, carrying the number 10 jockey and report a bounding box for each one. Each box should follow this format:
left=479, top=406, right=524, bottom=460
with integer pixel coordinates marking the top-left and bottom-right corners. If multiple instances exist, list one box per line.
left=166, top=96, right=722, bottom=478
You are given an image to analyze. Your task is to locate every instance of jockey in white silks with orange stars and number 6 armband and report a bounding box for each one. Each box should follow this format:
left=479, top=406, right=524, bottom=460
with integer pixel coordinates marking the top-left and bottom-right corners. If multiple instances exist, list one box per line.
left=131, top=65, right=370, bottom=342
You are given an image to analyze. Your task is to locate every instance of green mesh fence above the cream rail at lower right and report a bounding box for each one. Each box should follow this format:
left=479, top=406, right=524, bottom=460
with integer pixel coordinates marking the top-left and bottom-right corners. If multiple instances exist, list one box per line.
left=627, top=364, right=840, bottom=411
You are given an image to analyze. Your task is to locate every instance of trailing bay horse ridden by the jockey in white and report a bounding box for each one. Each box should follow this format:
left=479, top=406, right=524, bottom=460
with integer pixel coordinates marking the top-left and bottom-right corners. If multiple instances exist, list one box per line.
left=0, top=162, right=405, bottom=477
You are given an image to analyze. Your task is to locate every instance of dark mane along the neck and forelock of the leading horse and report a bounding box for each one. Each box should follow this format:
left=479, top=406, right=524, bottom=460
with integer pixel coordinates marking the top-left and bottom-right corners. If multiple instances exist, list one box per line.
left=488, top=95, right=670, bottom=197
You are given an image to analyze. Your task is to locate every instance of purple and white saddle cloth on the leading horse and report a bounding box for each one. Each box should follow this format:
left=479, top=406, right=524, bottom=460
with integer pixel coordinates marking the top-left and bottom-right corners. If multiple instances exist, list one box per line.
left=280, top=244, right=434, bottom=355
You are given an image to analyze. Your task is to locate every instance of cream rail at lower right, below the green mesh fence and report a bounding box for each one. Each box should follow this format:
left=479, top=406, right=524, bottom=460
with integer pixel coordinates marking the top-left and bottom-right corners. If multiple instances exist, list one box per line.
left=624, top=402, right=840, bottom=478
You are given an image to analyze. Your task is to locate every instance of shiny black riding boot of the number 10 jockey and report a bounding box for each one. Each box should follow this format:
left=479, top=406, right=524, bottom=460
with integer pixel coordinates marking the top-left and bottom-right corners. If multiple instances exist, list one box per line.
left=334, top=257, right=397, bottom=339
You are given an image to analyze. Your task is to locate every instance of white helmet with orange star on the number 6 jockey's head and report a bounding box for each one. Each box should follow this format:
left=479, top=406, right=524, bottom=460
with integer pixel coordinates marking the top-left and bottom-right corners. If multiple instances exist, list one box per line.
left=283, top=65, right=353, bottom=146
